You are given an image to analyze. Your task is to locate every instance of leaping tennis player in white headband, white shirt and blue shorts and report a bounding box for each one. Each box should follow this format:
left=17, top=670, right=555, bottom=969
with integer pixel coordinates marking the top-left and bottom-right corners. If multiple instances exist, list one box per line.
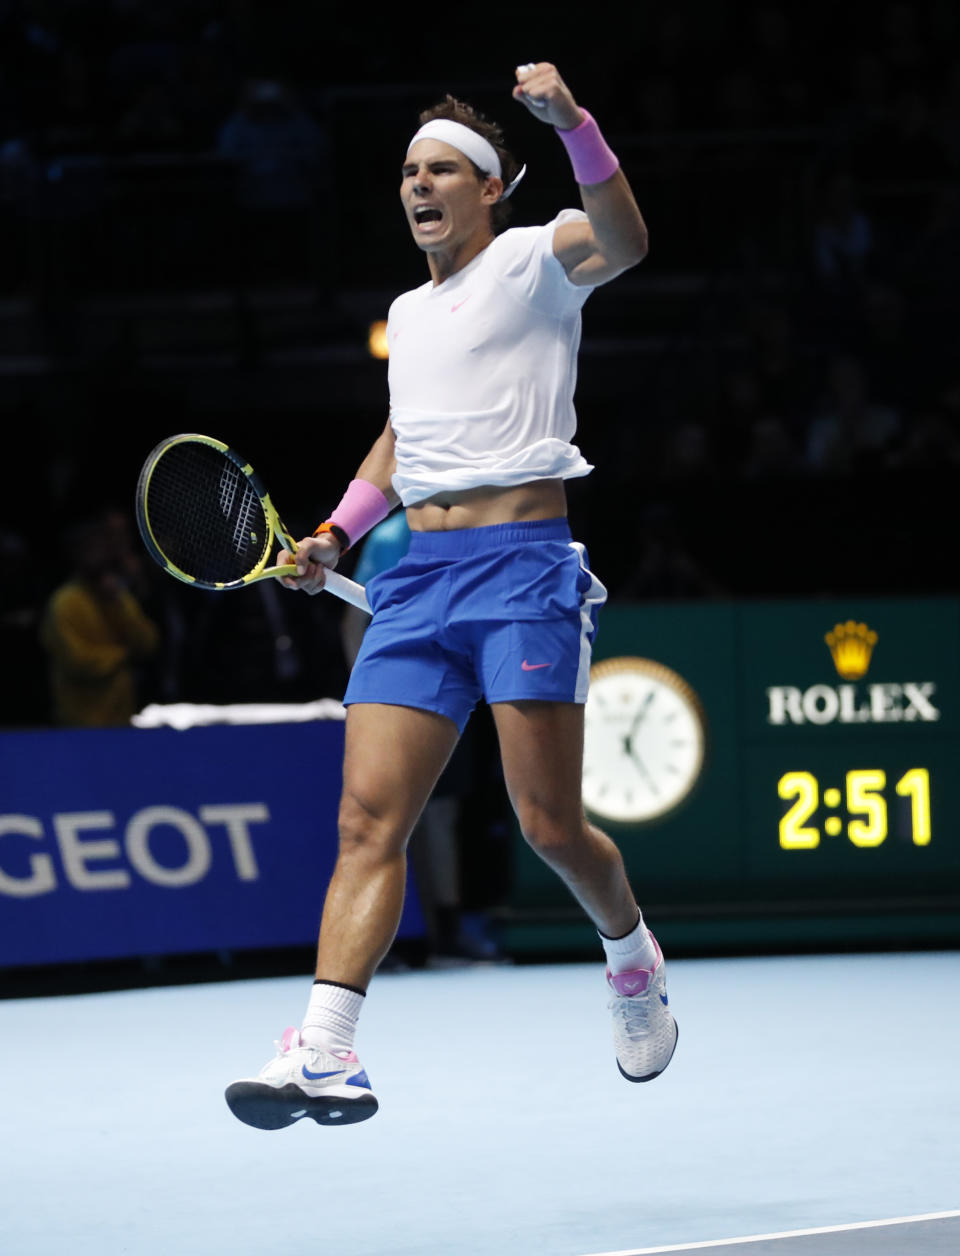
left=226, top=63, right=677, bottom=1129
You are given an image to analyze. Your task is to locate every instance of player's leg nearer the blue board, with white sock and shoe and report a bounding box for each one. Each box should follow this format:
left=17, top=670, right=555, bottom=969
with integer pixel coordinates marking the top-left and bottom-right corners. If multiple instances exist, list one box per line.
left=226, top=703, right=459, bottom=1129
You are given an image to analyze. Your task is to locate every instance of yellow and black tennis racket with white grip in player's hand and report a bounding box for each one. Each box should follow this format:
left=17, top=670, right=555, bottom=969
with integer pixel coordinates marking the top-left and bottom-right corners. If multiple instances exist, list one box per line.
left=137, top=432, right=369, bottom=614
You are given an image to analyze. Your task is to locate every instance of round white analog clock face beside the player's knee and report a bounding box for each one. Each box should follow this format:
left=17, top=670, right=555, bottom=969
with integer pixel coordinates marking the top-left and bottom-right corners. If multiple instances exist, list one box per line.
left=583, top=658, right=706, bottom=824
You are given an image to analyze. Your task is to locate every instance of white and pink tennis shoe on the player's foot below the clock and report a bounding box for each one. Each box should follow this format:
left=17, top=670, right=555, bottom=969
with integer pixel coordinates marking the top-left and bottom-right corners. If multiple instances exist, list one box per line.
left=607, top=934, right=677, bottom=1081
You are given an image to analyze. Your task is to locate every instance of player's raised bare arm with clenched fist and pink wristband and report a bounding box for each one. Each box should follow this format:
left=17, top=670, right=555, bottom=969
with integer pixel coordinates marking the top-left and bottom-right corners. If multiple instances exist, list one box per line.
left=513, top=62, right=647, bottom=285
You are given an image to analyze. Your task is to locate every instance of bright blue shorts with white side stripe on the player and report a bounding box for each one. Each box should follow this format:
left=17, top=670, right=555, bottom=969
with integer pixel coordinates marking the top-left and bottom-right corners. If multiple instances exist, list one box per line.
left=343, top=519, right=607, bottom=732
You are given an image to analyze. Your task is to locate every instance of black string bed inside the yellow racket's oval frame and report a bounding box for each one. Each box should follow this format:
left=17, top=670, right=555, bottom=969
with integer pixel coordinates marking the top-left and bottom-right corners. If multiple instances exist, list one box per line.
left=145, top=441, right=273, bottom=584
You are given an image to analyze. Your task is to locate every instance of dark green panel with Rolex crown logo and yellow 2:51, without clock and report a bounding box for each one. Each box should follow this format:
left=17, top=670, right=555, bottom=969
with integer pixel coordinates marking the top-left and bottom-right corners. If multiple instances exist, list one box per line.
left=738, top=599, right=960, bottom=911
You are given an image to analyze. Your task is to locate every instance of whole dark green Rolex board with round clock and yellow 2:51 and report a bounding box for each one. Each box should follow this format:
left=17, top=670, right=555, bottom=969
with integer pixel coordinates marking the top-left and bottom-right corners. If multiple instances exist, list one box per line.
left=513, top=598, right=960, bottom=946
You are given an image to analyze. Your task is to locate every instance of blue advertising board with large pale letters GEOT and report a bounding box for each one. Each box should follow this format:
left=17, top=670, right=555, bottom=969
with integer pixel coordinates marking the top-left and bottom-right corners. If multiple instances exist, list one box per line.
left=0, top=720, right=423, bottom=967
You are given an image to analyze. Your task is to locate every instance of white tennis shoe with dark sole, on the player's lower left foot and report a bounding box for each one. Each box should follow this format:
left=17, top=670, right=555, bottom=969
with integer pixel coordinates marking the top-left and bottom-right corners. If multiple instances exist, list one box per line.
left=226, top=1027, right=378, bottom=1129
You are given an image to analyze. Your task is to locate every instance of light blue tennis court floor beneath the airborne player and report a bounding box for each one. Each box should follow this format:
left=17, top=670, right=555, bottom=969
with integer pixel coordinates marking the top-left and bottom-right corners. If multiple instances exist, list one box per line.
left=0, top=952, right=960, bottom=1256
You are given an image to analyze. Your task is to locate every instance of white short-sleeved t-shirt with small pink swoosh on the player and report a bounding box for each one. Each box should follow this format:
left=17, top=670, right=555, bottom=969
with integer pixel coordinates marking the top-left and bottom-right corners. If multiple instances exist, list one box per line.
left=387, top=210, right=593, bottom=506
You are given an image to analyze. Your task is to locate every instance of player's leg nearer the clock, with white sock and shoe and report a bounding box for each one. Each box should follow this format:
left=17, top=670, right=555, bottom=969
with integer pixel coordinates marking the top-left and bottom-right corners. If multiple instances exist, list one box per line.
left=491, top=701, right=677, bottom=1081
